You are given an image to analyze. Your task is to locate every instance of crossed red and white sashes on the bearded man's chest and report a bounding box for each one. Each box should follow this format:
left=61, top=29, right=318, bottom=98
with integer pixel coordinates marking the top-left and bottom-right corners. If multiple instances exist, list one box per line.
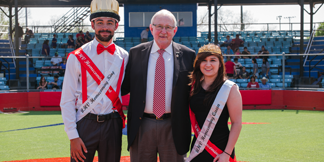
left=70, top=48, right=125, bottom=128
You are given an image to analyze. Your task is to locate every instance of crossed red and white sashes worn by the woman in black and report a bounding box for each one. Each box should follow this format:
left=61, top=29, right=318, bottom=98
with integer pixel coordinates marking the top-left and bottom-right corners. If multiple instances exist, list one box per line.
left=185, top=80, right=236, bottom=162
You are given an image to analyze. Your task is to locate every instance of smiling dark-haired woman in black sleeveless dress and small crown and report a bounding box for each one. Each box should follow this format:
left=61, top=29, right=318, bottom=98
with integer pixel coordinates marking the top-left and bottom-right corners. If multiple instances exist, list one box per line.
left=187, top=44, right=242, bottom=162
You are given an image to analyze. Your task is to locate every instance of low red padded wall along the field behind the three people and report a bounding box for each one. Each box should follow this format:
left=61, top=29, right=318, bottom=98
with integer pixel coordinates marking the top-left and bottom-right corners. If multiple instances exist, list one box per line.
left=0, top=90, right=324, bottom=111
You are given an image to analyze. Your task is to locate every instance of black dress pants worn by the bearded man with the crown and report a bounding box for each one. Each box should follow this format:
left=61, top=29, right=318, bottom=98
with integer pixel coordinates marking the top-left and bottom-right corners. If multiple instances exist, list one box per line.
left=71, top=113, right=123, bottom=162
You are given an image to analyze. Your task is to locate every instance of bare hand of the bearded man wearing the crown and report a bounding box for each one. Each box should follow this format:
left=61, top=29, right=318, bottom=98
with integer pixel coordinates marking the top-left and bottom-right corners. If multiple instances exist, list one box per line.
left=70, top=138, right=88, bottom=162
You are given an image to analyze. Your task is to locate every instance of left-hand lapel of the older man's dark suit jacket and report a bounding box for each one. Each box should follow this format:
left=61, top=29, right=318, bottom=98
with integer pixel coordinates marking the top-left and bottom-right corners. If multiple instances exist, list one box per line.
left=141, top=41, right=153, bottom=93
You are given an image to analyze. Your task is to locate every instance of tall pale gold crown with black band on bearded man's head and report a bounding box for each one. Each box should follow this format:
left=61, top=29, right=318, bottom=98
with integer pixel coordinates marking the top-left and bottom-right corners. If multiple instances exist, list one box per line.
left=90, top=0, right=120, bottom=22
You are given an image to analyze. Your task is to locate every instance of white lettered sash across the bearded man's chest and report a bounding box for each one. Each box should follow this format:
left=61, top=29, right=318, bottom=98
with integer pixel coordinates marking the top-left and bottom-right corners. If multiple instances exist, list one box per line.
left=76, top=50, right=123, bottom=121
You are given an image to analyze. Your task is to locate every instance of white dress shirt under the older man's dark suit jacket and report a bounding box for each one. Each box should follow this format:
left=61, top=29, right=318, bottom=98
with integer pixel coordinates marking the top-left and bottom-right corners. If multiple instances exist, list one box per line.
left=144, top=41, right=174, bottom=114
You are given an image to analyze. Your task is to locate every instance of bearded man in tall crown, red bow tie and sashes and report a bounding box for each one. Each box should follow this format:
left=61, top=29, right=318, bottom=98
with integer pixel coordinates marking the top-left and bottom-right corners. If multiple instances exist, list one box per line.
left=60, top=0, right=128, bottom=162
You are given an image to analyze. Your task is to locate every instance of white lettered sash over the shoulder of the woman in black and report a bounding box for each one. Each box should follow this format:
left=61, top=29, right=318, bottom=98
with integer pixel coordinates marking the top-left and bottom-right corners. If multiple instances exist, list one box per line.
left=185, top=80, right=235, bottom=162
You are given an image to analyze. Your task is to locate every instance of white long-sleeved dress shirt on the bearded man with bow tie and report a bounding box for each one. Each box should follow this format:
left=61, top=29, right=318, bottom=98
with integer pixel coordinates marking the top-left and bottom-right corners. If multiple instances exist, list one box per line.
left=60, top=39, right=128, bottom=139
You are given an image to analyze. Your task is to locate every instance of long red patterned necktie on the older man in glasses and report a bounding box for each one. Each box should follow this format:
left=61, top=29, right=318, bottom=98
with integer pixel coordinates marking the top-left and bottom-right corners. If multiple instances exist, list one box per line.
left=153, top=49, right=165, bottom=118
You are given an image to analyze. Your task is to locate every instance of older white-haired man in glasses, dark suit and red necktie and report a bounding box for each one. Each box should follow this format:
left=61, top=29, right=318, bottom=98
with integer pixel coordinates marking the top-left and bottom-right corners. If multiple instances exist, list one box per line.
left=122, top=10, right=195, bottom=162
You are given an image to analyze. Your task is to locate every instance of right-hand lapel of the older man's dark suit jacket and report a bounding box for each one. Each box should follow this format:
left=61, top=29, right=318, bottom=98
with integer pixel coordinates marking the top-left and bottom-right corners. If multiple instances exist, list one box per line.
left=172, top=42, right=183, bottom=87
